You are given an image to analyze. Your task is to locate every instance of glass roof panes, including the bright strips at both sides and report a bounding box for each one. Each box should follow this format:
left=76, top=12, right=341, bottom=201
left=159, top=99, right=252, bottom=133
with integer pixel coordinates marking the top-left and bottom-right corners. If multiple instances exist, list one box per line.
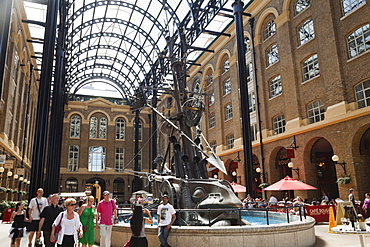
left=24, top=0, right=249, bottom=98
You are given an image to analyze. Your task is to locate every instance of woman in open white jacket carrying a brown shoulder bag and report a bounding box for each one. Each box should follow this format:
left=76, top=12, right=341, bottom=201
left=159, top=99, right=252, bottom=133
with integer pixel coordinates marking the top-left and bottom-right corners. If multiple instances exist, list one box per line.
left=50, top=198, right=82, bottom=247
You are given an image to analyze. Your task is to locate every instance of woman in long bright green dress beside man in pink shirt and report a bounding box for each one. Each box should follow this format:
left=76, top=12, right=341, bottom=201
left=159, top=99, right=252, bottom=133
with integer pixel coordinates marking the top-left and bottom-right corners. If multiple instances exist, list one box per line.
left=78, top=196, right=96, bottom=247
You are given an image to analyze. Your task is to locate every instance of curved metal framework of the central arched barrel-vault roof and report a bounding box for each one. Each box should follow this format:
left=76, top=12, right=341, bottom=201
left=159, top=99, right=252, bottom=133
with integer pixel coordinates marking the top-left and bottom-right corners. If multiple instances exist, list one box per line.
left=64, top=0, right=231, bottom=101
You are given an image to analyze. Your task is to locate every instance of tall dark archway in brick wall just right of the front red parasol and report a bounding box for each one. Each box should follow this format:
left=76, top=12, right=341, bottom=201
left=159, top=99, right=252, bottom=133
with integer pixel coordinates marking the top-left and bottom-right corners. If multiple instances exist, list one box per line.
left=311, top=138, right=339, bottom=198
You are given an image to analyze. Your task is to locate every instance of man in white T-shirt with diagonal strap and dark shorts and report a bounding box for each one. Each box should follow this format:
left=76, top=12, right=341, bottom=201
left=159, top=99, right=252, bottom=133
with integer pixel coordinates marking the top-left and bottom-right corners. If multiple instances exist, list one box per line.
left=28, top=188, right=48, bottom=247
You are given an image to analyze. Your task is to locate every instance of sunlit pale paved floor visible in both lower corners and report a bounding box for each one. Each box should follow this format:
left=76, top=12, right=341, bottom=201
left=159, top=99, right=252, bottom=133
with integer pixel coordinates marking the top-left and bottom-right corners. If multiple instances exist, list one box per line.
left=0, top=223, right=370, bottom=247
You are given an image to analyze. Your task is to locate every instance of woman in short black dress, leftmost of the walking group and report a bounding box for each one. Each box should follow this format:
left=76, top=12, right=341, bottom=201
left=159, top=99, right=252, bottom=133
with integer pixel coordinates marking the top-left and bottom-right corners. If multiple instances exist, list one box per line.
left=9, top=202, right=28, bottom=247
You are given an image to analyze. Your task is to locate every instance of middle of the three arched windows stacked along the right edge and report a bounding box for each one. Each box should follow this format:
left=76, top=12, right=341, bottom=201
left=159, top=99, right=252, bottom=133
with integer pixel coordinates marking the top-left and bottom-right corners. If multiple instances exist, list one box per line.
left=347, top=24, right=370, bottom=58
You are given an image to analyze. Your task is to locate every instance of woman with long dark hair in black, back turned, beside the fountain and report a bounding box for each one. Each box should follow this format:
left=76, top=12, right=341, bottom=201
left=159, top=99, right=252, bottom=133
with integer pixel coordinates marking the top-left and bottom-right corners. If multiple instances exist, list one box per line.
left=129, top=205, right=153, bottom=247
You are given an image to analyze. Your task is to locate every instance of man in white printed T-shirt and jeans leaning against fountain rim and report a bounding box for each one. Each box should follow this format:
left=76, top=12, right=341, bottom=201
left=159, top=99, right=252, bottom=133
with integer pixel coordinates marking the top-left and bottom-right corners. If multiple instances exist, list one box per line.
left=157, top=194, right=176, bottom=247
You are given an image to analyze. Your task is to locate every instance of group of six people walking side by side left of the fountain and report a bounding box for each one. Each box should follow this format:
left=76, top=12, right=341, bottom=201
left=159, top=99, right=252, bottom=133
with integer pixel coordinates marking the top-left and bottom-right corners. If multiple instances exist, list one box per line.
left=9, top=188, right=118, bottom=247
